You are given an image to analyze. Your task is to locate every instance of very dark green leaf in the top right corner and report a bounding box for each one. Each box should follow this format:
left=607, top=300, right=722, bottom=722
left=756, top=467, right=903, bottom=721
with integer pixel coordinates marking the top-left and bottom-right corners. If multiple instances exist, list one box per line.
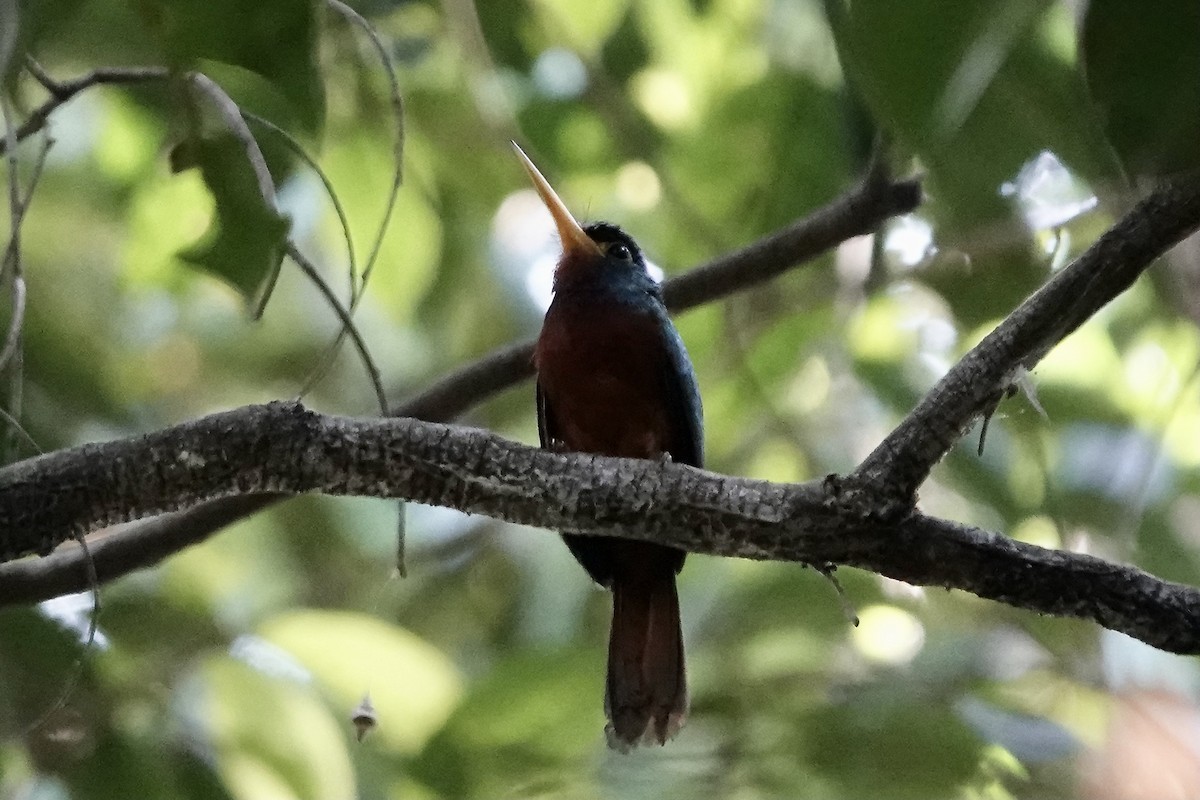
left=1082, top=0, right=1200, bottom=176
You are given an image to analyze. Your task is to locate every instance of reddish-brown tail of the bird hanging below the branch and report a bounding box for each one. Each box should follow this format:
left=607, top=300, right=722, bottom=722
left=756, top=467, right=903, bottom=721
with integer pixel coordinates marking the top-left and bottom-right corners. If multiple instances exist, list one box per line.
left=605, top=571, right=688, bottom=751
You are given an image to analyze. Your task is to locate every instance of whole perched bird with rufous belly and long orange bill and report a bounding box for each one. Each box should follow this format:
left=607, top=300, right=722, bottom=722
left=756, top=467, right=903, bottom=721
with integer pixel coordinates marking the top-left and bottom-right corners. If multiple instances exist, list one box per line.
left=512, top=142, right=704, bottom=752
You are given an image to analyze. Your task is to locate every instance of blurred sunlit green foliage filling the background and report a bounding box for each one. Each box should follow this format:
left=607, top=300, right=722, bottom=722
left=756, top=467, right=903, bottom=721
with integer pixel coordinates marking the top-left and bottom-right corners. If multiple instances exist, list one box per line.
left=0, top=0, right=1200, bottom=800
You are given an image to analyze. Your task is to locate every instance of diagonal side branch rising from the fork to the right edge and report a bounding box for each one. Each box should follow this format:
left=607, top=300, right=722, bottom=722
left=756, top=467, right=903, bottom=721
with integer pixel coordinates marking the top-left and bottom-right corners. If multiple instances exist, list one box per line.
left=856, top=175, right=1200, bottom=503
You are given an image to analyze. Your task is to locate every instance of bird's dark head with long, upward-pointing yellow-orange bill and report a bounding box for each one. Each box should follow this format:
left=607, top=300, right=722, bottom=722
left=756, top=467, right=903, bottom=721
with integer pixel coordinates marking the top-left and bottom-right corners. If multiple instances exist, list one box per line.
left=512, top=142, right=654, bottom=291
